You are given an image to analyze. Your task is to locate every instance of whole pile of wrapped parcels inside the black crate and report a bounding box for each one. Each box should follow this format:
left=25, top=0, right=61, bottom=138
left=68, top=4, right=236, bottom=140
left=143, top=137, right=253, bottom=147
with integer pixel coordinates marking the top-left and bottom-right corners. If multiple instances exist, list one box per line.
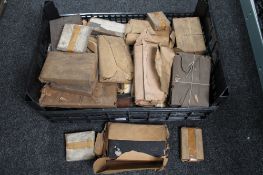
left=39, top=12, right=211, bottom=108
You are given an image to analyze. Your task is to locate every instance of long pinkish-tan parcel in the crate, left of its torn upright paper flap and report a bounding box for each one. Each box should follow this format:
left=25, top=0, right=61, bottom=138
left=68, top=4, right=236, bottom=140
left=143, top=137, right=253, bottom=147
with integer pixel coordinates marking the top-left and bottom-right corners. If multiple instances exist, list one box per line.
left=134, top=41, right=166, bottom=106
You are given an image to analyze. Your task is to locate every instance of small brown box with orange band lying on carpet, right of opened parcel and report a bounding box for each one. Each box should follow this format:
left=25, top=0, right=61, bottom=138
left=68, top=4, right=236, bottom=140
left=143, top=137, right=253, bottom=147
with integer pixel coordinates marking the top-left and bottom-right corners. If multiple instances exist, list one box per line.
left=181, top=127, right=204, bottom=162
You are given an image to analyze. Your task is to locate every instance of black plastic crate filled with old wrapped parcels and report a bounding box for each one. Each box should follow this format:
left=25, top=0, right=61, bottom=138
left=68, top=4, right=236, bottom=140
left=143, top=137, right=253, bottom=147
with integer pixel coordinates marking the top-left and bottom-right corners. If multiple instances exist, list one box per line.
left=25, top=0, right=228, bottom=123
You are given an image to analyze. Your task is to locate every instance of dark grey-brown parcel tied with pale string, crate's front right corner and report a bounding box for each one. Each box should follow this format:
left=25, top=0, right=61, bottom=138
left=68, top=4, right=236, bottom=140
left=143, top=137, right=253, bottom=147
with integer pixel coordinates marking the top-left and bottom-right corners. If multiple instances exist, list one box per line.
left=171, top=52, right=211, bottom=107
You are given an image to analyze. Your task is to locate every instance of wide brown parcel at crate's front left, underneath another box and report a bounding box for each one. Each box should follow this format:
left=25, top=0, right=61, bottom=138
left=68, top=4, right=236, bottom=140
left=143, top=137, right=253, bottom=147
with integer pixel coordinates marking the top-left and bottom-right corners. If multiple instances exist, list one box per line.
left=39, top=83, right=117, bottom=108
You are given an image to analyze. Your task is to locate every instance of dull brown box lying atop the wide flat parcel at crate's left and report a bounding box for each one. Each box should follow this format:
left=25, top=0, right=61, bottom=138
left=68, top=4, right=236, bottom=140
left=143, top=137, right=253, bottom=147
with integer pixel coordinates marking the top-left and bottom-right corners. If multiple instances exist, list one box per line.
left=39, top=51, right=98, bottom=88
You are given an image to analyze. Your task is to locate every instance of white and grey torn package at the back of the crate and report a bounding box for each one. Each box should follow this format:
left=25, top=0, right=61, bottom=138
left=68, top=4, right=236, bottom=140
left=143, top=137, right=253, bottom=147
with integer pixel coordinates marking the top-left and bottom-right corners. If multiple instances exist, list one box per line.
left=88, top=18, right=126, bottom=37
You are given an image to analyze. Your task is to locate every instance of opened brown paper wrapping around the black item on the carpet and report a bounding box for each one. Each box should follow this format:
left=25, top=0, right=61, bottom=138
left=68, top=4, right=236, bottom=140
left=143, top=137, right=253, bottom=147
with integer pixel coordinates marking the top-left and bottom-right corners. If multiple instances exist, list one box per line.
left=93, top=123, right=169, bottom=174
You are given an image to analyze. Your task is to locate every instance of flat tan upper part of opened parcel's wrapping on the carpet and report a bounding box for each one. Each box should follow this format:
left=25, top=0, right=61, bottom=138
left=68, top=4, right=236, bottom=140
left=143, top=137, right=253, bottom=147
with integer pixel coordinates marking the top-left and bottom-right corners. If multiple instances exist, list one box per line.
left=107, top=123, right=169, bottom=141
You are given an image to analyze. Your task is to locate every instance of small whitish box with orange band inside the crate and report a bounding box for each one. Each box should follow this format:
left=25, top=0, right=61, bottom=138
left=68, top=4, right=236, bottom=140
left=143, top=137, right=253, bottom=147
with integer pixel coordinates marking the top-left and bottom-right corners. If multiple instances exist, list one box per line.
left=57, top=24, right=92, bottom=53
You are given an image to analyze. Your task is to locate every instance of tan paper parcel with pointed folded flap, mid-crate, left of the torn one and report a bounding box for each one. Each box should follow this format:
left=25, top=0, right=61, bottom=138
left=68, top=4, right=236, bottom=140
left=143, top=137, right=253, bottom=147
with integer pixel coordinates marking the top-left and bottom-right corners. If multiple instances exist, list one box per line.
left=98, top=35, right=134, bottom=83
